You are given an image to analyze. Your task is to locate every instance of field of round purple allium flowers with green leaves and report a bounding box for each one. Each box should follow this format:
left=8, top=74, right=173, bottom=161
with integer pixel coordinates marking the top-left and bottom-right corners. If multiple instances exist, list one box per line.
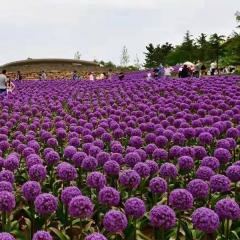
left=0, top=74, right=240, bottom=240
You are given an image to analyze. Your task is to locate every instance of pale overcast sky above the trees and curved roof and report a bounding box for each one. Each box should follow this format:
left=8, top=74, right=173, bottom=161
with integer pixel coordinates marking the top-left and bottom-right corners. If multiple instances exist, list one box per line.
left=0, top=0, right=240, bottom=65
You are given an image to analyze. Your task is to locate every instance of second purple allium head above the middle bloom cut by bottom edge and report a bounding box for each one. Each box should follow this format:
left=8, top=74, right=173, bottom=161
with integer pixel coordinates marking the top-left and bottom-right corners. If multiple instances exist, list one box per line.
left=22, top=181, right=41, bottom=201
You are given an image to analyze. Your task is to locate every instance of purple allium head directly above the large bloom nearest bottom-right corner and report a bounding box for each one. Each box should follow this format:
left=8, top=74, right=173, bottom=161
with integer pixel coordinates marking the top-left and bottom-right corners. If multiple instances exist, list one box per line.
left=210, top=174, right=231, bottom=192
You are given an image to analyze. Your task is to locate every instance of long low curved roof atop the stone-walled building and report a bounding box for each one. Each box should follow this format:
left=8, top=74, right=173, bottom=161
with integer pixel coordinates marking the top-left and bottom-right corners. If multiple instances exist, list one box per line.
left=1, top=58, right=99, bottom=67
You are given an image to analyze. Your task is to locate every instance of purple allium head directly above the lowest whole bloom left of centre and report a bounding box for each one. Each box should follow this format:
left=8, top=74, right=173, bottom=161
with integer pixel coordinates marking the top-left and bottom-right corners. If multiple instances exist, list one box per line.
left=98, top=187, right=120, bottom=207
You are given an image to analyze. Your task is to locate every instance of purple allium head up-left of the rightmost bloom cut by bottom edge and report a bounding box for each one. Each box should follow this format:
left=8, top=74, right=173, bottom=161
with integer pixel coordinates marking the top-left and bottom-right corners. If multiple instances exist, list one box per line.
left=68, top=196, right=94, bottom=219
